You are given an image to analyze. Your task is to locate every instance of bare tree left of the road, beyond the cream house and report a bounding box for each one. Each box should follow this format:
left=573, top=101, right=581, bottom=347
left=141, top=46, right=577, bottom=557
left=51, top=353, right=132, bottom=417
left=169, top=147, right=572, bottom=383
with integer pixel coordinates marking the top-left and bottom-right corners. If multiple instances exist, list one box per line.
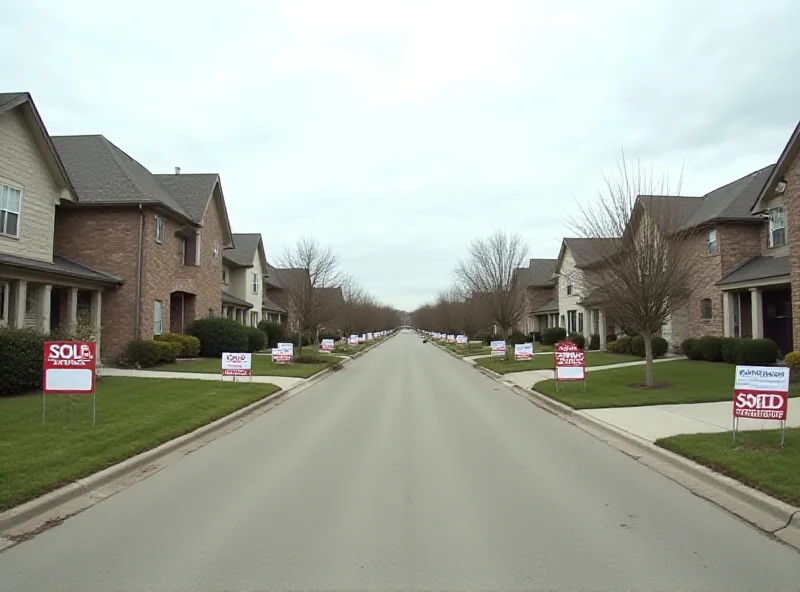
left=277, top=238, right=344, bottom=351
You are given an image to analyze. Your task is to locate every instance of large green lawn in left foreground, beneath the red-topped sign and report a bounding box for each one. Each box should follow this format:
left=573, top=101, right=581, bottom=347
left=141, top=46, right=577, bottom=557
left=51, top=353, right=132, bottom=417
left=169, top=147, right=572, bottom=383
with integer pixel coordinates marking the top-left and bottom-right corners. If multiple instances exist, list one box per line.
left=0, top=377, right=278, bottom=510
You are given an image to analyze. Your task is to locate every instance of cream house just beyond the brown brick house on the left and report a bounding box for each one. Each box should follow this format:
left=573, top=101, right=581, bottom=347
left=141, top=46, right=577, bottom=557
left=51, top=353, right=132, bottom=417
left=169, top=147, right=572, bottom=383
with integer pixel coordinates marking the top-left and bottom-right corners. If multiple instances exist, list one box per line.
left=222, top=233, right=276, bottom=327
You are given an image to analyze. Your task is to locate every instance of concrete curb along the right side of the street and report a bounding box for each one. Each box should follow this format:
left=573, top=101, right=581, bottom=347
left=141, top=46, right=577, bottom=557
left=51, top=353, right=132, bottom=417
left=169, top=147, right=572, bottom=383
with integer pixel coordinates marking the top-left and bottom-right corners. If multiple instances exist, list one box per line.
left=476, top=366, right=800, bottom=550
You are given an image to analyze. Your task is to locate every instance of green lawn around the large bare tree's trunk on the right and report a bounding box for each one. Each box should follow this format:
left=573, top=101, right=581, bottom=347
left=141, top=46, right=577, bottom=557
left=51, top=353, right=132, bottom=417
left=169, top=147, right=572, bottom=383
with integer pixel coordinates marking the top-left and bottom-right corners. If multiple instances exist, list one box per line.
left=535, top=354, right=800, bottom=409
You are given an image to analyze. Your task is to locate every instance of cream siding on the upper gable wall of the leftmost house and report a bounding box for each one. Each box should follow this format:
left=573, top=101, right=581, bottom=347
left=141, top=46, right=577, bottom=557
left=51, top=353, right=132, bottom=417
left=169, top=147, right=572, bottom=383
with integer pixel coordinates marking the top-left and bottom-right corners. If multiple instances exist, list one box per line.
left=0, top=108, right=62, bottom=262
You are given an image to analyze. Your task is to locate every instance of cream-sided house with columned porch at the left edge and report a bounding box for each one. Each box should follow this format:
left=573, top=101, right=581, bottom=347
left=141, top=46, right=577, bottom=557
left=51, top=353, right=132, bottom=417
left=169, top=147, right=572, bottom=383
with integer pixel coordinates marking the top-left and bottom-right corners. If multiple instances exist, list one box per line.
left=0, top=93, right=124, bottom=350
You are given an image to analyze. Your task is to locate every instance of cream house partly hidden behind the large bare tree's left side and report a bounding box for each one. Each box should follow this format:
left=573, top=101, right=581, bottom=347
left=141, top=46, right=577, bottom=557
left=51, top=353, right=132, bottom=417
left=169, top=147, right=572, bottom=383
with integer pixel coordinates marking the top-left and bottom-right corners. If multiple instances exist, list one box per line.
left=546, top=238, right=617, bottom=348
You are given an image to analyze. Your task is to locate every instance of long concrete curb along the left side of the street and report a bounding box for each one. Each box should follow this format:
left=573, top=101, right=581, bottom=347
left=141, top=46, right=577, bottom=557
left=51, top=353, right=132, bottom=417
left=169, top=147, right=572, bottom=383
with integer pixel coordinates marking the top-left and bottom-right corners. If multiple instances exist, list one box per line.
left=0, top=336, right=393, bottom=536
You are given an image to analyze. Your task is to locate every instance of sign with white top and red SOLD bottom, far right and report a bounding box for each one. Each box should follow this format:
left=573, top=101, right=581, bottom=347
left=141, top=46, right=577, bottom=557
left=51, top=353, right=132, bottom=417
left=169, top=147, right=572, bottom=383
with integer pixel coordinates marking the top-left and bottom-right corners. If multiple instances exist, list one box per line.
left=733, top=366, right=789, bottom=421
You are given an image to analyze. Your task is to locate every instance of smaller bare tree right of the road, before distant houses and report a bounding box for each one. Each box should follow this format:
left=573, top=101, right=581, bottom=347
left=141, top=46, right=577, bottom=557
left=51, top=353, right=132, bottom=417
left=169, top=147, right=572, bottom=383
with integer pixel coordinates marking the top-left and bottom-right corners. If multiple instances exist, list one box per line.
left=456, top=230, right=528, bottom=354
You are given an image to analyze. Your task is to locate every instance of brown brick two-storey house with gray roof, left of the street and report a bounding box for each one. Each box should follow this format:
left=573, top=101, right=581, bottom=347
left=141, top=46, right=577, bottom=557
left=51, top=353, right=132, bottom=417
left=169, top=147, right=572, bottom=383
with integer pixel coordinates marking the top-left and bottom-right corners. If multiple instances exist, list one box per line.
left=52, top=135, right=234, bottom=357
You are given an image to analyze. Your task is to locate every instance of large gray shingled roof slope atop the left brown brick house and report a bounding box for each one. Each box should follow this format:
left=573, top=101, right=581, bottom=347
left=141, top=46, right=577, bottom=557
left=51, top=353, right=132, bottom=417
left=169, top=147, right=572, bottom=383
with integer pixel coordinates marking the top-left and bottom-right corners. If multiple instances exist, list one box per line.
left=53, top=135, right=194, bottom=221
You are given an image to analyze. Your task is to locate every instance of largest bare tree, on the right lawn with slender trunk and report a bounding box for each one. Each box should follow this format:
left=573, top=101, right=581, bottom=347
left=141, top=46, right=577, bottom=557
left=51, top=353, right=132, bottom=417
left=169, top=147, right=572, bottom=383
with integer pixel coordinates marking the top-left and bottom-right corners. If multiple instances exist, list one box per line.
left=570, top=154, right=699, bottom=388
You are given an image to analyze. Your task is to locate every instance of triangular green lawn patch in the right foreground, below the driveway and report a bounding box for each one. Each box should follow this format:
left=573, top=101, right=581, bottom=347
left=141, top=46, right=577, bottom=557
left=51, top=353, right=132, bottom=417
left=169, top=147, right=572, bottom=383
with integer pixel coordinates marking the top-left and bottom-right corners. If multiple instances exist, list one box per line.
left=656, top=428, right=800, bottom=506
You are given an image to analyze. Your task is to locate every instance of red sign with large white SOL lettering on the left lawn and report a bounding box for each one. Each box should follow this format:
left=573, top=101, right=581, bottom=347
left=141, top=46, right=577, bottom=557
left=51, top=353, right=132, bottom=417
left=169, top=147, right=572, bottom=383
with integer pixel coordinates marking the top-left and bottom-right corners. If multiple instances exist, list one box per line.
left=42, top=341, right=97, bottom=395
